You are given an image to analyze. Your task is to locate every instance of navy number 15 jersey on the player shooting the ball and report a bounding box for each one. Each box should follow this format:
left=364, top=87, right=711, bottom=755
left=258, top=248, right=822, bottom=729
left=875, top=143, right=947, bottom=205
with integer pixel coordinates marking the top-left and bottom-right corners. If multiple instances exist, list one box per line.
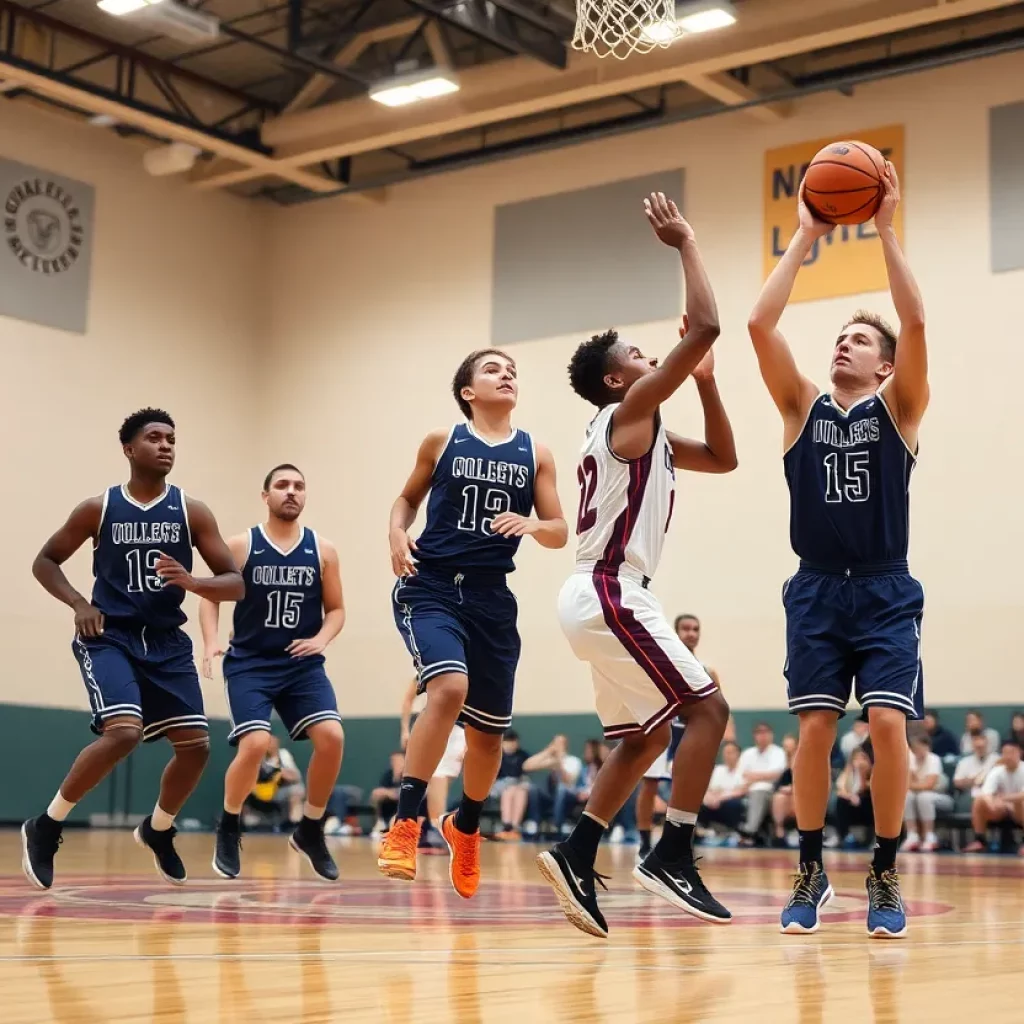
left=783, top=392, right=914, bottom=569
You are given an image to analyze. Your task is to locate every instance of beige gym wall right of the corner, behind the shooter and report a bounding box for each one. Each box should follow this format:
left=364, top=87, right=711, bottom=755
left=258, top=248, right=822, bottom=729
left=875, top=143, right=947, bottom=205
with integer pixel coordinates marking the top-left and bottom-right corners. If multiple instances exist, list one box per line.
left=266, top=54, right=1024, bottom=715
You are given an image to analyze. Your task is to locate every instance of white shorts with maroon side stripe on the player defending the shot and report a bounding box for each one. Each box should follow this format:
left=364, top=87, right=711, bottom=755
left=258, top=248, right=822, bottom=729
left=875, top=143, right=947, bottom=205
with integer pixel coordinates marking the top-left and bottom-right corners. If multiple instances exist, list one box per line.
left=558, top=572, right=718, bottom=739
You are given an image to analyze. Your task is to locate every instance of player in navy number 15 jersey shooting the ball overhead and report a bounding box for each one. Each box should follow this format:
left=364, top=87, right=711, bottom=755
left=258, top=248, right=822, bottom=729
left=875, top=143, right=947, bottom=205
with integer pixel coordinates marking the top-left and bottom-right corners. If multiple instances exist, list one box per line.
left=749, top=164, right=929, bottom=938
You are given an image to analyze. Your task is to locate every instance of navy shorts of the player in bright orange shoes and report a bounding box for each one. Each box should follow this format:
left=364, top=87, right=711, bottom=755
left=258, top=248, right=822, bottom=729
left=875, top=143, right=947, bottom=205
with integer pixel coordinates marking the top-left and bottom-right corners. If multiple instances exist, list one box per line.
left=391, top=568, right=521, bottom=733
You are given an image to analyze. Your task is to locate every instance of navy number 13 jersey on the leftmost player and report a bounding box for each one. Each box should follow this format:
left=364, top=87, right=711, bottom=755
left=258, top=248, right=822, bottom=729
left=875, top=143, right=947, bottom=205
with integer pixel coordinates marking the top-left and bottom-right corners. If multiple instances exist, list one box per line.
left=92, top=484, right=191, bottom=629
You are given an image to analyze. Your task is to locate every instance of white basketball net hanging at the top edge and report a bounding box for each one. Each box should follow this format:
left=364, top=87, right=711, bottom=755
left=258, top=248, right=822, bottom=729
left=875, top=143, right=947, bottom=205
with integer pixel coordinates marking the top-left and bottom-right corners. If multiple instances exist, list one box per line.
left=572, top=0, right=679, bottom=60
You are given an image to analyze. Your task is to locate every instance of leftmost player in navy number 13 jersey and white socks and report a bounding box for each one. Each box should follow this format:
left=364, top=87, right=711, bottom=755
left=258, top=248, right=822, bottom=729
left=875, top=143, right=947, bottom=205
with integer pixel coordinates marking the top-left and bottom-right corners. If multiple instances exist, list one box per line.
left=22, top=409, right=244, bottom=889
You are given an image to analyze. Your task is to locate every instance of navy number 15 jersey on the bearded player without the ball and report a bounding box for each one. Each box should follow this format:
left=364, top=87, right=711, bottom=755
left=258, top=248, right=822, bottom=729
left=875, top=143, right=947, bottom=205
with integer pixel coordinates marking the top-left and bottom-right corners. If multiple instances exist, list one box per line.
left=231, top=526, right=324, bottom=654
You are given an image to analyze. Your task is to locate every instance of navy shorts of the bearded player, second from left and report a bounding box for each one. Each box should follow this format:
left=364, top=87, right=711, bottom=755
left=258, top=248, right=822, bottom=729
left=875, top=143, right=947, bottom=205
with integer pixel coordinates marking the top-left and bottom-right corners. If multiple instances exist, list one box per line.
left=224, top=651, right=341, bottom=746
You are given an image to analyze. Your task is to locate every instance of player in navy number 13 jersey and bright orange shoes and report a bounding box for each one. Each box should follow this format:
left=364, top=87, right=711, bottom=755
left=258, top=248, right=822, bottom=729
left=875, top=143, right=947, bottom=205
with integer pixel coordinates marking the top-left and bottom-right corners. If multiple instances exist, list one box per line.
left=378, top=349, right=567, bottom=899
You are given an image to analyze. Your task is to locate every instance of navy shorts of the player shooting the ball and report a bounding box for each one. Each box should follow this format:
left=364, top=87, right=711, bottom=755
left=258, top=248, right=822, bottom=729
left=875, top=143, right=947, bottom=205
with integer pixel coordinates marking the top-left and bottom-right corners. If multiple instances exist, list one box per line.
left=782, top=568, right=925, bottom=719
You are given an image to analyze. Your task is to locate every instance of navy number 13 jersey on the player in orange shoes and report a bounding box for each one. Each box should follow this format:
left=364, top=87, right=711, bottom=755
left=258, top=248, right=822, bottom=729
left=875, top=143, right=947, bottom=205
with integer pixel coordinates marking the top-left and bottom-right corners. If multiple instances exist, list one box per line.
left=416, top=423, right=537, bottom=572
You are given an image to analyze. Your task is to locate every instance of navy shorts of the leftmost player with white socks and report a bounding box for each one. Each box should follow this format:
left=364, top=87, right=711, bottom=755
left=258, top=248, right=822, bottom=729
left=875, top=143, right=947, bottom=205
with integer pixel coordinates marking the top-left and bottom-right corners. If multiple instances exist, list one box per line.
left=72, top=621, right=209, bottom=743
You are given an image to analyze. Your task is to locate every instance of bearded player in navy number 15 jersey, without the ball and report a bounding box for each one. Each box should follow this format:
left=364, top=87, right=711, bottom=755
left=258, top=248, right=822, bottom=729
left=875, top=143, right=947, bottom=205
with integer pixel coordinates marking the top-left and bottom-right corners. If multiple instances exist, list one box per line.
left=199, top=463, right=345, bottom=882
